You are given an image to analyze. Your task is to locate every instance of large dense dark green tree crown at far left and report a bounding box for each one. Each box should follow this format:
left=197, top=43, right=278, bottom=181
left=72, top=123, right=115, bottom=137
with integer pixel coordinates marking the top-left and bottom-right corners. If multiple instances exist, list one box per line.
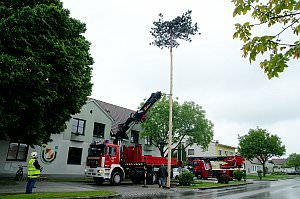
left=0, top=0, right=93, bottom=145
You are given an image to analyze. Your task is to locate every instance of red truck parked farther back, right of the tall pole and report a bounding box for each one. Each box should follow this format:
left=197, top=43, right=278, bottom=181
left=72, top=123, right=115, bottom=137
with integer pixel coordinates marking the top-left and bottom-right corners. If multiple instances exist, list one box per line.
left=188, top=155, right=245, bottom=182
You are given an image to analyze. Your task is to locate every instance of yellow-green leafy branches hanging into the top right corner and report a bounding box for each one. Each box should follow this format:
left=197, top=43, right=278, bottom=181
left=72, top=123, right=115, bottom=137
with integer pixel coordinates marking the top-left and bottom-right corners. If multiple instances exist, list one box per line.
left=233, top=0, right=300, bottom=79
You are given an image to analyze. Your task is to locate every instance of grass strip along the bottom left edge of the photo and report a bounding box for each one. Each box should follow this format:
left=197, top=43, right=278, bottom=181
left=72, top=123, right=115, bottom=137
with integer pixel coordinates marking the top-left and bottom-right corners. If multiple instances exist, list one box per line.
left=0, top=191, right=116, bottom=199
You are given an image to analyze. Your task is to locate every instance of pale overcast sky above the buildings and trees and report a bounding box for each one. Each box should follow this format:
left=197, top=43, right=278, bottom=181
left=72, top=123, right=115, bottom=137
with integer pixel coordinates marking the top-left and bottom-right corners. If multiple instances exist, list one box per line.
left=63, top=0, right=300, bottom=155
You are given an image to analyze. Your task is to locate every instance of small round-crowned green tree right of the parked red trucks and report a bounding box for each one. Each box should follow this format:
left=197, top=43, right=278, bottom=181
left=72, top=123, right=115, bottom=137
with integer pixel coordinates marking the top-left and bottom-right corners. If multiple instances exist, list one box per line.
left=239, top=127, right=285, bottom=176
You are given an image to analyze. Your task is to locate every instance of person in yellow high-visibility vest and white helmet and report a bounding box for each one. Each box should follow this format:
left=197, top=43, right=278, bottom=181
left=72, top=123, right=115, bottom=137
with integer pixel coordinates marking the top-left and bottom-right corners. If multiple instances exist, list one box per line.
left=26, top=152, right=42, bottom=194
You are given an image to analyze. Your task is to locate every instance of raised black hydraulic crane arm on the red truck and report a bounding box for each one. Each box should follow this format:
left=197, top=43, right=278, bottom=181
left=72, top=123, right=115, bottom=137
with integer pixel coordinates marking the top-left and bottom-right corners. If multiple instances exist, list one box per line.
left=112, top=91, right=162, bottom=144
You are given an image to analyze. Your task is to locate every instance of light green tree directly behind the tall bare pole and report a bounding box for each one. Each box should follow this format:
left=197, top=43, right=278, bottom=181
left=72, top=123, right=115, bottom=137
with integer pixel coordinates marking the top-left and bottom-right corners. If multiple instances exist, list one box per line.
left=141, top=96, right=213, bottom=157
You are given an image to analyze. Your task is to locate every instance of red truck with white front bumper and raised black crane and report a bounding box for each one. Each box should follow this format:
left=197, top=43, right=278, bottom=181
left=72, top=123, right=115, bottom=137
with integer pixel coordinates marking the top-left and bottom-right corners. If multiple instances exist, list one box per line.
left=85, top=92, right=177, bottom=185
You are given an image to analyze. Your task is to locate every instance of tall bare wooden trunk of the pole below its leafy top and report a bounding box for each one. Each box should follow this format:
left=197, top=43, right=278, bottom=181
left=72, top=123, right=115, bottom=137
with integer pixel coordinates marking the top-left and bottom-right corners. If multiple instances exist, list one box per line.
left=167, top=47, right=173, bottom=188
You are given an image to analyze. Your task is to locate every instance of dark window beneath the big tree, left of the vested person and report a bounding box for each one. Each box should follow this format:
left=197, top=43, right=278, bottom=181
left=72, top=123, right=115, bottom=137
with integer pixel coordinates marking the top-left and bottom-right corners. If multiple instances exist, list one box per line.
left=6, top=142, right=28, bottom=162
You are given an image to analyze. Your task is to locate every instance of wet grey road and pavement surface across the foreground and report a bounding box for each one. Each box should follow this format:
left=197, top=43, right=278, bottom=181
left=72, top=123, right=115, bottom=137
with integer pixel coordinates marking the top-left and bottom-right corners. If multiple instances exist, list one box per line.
left=0, top=177, right=300, bottom=199
